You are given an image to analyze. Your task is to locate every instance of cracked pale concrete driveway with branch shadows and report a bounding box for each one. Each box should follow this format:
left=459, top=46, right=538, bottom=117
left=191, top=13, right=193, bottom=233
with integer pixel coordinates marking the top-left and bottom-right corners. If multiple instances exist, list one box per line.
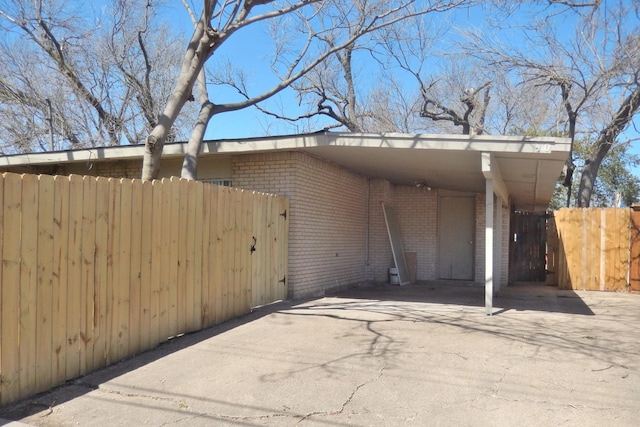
left=0, top=284, right=640, bottom=427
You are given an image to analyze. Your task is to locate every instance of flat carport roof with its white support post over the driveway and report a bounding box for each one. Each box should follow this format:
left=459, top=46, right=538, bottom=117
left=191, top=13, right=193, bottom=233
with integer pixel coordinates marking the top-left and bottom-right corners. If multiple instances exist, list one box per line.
left=278, top=133, right=570, bottom=315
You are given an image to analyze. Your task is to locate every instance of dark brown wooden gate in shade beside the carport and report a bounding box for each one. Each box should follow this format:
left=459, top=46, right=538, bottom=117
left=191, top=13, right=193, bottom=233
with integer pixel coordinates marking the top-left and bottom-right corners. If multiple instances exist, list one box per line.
left=509, top=211, right=548, bottom=282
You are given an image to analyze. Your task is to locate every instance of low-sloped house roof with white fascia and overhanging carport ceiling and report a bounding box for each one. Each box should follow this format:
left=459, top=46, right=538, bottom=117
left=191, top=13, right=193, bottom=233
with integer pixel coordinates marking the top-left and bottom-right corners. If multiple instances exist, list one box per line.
left=0, top=132, right=570, bottom=211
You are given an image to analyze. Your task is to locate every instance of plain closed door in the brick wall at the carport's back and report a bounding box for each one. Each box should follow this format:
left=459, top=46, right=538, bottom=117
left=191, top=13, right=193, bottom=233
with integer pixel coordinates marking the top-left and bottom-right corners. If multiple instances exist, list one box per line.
left=438, top=196, right=475, bottom=280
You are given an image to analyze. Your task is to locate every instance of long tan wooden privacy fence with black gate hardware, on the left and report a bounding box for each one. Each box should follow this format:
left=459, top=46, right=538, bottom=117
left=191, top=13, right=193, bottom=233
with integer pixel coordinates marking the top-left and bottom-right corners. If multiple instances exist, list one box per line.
left=0, top=173, right=289, bottom=404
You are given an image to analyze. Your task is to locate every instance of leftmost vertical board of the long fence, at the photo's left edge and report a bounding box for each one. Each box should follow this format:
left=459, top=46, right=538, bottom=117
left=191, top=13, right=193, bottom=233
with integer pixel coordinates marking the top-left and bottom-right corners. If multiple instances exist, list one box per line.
left=0, top=173, right=22, bottom=404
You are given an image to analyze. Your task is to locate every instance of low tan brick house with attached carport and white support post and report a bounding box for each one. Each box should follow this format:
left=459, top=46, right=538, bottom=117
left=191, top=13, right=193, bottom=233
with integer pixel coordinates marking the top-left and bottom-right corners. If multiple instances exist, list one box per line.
left=0, top=132, right=570, bottom=306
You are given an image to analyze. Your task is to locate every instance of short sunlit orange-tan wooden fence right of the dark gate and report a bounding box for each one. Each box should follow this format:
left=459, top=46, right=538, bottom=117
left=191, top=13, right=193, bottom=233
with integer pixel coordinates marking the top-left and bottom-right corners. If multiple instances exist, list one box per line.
left=547, top=208, right=640, bottom=291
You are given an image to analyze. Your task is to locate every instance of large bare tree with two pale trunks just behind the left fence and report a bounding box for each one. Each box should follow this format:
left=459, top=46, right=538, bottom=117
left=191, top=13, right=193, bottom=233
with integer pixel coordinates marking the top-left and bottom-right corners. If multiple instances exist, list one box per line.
left=142, top=0, right=476, bottom=179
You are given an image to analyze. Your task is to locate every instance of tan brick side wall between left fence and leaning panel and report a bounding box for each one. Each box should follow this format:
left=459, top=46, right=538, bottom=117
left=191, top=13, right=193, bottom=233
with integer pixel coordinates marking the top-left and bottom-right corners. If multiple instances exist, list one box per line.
left=232, top=152, right=367, bottom=299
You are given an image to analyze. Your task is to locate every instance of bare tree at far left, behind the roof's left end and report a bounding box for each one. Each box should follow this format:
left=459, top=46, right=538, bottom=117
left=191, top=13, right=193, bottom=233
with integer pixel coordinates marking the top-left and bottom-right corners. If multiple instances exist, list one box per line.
left=0, top=0, right=190, bottom=151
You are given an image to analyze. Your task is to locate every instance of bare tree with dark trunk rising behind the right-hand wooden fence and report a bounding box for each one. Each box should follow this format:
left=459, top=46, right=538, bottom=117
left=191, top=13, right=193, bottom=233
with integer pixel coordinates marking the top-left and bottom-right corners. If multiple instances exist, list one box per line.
left=467, top=2, right=640, bottom=207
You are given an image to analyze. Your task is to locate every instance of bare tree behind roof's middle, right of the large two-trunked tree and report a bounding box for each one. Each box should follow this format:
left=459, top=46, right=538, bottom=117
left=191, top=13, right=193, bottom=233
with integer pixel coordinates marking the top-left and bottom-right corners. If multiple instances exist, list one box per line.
left=250, top=0, right=475, bottom=132
